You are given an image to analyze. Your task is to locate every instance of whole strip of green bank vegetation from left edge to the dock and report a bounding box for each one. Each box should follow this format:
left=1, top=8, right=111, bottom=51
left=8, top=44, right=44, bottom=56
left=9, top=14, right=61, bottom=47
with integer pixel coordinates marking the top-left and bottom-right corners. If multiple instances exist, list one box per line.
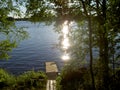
left=0, top=69, right=47, bottom=90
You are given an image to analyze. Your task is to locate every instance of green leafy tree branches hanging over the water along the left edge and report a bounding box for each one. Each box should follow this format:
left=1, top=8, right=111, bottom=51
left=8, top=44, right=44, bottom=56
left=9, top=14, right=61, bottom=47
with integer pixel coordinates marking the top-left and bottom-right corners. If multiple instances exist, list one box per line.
left=0, top=0, right=27, bottom=59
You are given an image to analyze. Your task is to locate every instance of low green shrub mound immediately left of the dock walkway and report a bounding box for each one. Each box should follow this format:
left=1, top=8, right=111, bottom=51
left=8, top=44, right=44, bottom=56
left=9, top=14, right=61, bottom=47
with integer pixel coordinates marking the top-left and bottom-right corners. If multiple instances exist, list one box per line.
left=16, top=71, right=47, bottom=90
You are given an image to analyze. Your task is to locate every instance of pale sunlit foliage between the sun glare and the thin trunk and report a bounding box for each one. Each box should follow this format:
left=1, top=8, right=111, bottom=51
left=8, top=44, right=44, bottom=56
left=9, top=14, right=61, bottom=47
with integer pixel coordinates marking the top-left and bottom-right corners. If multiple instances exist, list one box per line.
left=69, top=21, right=89, bottom=61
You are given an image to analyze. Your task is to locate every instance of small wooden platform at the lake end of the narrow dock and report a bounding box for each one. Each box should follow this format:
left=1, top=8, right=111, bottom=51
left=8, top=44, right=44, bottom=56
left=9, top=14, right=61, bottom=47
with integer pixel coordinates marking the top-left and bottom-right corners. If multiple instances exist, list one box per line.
left=45, top=62, right=58, bottom=80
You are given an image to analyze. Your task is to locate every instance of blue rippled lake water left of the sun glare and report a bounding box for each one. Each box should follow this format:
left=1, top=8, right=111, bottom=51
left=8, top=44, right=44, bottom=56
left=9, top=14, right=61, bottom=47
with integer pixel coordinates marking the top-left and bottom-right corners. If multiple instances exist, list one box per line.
left=0, top=21, right=62, bottom=75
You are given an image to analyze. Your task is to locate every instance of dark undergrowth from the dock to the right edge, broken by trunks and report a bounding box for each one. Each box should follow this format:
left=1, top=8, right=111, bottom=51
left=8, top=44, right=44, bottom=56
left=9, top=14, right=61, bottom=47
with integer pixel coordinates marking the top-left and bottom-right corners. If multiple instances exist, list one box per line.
left=56, top=63, right=120, bottom=90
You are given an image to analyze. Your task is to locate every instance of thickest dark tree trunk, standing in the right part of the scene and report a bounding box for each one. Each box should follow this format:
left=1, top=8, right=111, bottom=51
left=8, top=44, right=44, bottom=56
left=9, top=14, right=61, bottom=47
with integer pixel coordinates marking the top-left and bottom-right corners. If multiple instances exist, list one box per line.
left=99, top=0, right=109, bottom=90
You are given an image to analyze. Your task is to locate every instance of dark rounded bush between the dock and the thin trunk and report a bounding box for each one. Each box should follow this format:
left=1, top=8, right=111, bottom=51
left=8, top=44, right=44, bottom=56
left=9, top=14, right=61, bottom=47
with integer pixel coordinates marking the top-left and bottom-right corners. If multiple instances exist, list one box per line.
left=56, top=65, right=92, bottom=90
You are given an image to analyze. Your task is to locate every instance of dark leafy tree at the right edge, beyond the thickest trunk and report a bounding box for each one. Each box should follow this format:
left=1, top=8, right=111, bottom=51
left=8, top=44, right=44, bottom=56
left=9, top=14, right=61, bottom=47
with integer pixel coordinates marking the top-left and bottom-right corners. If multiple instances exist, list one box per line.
left=107, top=0, right=120, bottom=73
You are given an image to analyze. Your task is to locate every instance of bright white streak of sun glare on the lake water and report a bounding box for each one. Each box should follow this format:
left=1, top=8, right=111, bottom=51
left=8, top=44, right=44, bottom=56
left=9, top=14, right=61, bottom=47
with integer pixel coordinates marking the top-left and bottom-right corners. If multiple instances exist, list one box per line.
left=62, top=21, right=70, bottom=60
